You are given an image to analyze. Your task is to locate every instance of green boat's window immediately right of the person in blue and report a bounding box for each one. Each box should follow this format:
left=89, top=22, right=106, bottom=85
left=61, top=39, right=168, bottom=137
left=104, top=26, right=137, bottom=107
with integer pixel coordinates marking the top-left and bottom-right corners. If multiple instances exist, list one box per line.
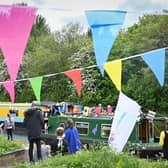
left=75, top=122, right=89, bottom=135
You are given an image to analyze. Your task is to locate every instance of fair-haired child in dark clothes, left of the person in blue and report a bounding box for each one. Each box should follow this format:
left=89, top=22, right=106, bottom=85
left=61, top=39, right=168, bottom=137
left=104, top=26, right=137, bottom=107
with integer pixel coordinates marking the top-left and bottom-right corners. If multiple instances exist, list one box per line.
left=50, top=127, right=69, bottom=156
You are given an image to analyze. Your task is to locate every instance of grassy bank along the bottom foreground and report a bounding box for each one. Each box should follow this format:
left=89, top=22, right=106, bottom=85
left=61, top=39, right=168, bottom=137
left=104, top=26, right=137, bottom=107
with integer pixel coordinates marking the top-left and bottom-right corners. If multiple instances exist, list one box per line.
left=16, top=149, right=168, bottom=168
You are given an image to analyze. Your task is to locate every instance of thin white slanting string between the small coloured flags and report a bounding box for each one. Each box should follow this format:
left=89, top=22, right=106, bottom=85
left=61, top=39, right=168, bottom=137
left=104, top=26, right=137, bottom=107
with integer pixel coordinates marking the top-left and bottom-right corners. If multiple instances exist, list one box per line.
left=0, top=47, right=168, bottom=84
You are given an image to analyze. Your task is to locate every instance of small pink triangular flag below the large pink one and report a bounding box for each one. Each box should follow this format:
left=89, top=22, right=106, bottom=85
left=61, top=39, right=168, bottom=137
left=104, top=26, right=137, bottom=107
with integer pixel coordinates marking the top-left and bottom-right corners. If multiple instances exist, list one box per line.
left=2, top=81, right=15, bottom=103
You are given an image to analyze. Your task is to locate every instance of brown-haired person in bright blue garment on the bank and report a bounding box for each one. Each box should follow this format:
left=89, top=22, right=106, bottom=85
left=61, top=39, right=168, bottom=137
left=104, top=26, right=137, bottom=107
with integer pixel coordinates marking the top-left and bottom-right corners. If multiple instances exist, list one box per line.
left=65, top=119, right=81, bottom=153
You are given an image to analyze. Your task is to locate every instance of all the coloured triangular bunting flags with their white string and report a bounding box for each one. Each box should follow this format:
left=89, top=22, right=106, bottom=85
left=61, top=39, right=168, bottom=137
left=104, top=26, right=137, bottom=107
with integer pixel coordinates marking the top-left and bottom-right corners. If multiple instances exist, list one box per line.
left=0, top=5, right=166, bottom=102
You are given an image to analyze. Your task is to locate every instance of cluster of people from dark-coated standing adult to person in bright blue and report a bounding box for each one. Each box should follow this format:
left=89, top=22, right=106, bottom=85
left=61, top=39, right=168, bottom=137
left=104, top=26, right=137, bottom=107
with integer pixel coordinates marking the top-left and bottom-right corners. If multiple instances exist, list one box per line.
left=24, top=103, right=81, bottom=162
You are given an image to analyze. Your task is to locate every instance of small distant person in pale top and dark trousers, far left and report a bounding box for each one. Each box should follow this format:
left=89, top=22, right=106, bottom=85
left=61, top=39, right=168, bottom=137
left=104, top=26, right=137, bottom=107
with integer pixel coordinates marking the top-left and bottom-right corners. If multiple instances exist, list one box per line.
left=4, top=114, right=15, bottom=140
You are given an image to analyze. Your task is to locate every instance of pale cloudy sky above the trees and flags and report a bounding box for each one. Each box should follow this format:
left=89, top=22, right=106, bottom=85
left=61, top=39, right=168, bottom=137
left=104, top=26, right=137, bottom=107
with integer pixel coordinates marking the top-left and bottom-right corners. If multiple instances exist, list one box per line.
left=0, top=0, right=168, bottom=31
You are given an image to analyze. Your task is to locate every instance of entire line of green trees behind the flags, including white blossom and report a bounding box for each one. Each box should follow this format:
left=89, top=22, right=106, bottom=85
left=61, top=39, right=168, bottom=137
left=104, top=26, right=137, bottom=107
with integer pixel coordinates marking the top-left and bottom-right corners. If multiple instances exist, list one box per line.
left=0, top=10, right=168, bottom=115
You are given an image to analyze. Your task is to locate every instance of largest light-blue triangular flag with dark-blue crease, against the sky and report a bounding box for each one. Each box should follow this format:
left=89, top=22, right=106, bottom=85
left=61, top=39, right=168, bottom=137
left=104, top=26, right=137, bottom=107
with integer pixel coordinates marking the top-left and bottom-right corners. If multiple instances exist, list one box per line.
left=85, top=10, right=126, bottom=75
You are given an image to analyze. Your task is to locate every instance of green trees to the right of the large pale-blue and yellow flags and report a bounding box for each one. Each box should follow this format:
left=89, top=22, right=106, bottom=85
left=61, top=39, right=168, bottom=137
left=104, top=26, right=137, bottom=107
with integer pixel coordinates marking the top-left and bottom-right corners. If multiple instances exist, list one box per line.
left=109, top=11, right=168, bottom=114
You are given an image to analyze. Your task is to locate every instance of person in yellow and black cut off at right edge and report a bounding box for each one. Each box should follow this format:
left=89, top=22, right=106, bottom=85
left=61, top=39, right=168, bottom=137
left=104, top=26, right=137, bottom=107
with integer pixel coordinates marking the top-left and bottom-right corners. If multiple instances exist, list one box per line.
left=159, top=122, right=168, bottom=159
